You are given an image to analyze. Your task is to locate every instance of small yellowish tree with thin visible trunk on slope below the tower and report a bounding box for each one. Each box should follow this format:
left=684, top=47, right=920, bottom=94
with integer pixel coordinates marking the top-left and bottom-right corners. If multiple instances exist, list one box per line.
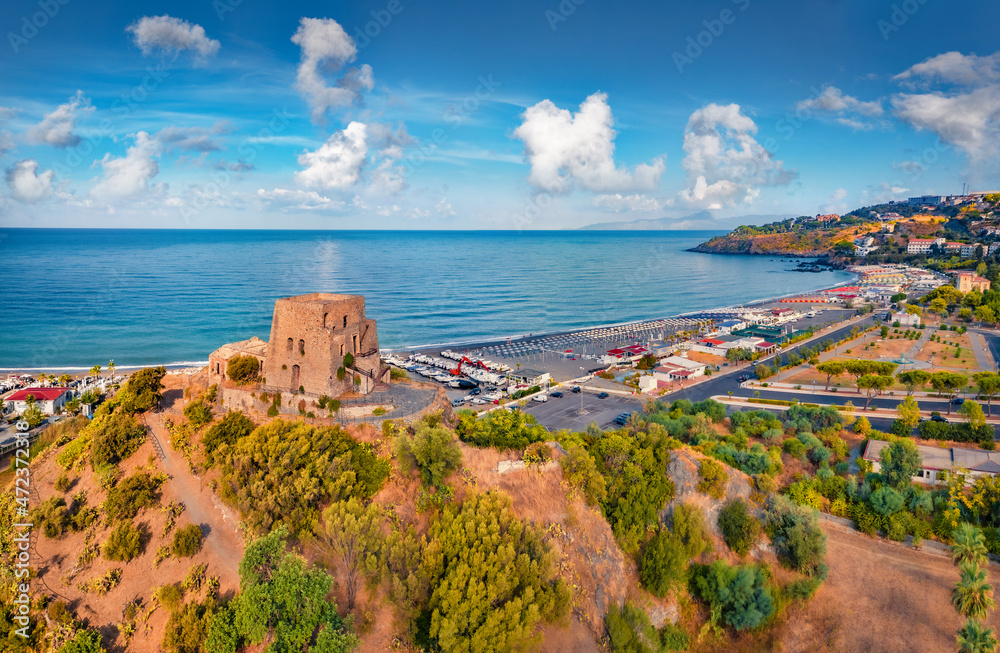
left=314, top=497, right=383, bottom=610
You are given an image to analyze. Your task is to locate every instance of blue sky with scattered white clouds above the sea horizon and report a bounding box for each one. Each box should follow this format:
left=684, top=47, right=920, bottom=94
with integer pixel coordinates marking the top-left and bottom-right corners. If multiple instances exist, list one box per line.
left=0, top=0, right=1000, bottom=230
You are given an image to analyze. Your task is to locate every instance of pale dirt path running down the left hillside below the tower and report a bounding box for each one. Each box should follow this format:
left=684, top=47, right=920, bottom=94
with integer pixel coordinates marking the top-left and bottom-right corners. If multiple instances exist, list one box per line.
left=146, top=413, right=243, bottom=574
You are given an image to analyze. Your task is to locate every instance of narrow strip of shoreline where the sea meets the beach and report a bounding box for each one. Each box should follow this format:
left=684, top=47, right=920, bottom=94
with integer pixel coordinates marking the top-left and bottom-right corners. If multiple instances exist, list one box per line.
left=0, top=264, right=861, bottom=376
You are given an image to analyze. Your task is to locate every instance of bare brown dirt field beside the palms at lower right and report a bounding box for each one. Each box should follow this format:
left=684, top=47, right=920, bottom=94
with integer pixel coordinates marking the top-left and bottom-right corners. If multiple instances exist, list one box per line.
left=783, top=522, right=1000, bottom=653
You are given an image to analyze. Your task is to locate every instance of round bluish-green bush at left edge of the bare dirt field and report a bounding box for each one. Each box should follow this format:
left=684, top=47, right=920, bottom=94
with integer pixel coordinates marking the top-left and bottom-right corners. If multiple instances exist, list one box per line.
left=690, top=560, right=774, bottom=630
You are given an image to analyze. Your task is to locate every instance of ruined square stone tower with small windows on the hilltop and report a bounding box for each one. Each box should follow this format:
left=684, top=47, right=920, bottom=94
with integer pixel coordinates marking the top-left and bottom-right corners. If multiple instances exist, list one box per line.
left=263, top=293, right=389, bottom=397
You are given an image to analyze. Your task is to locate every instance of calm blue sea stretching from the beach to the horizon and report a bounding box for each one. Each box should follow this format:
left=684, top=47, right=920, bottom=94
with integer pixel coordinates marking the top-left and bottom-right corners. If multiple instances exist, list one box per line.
left=0, top=229, right=854, bottom=371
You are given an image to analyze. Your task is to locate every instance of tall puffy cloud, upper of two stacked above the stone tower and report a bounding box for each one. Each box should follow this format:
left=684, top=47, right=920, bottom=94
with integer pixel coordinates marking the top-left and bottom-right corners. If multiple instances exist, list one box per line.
left=292, top=18, right=375, bottom=123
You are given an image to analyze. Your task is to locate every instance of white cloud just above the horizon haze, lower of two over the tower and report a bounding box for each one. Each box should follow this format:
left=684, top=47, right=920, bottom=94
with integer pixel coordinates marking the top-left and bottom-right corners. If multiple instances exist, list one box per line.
left=295, top=122, right=368, bottom=190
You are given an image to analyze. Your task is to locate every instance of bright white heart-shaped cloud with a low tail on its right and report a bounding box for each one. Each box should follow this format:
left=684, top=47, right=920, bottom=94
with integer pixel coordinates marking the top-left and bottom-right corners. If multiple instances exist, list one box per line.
left=514, top=93, right=665, bottom=193
